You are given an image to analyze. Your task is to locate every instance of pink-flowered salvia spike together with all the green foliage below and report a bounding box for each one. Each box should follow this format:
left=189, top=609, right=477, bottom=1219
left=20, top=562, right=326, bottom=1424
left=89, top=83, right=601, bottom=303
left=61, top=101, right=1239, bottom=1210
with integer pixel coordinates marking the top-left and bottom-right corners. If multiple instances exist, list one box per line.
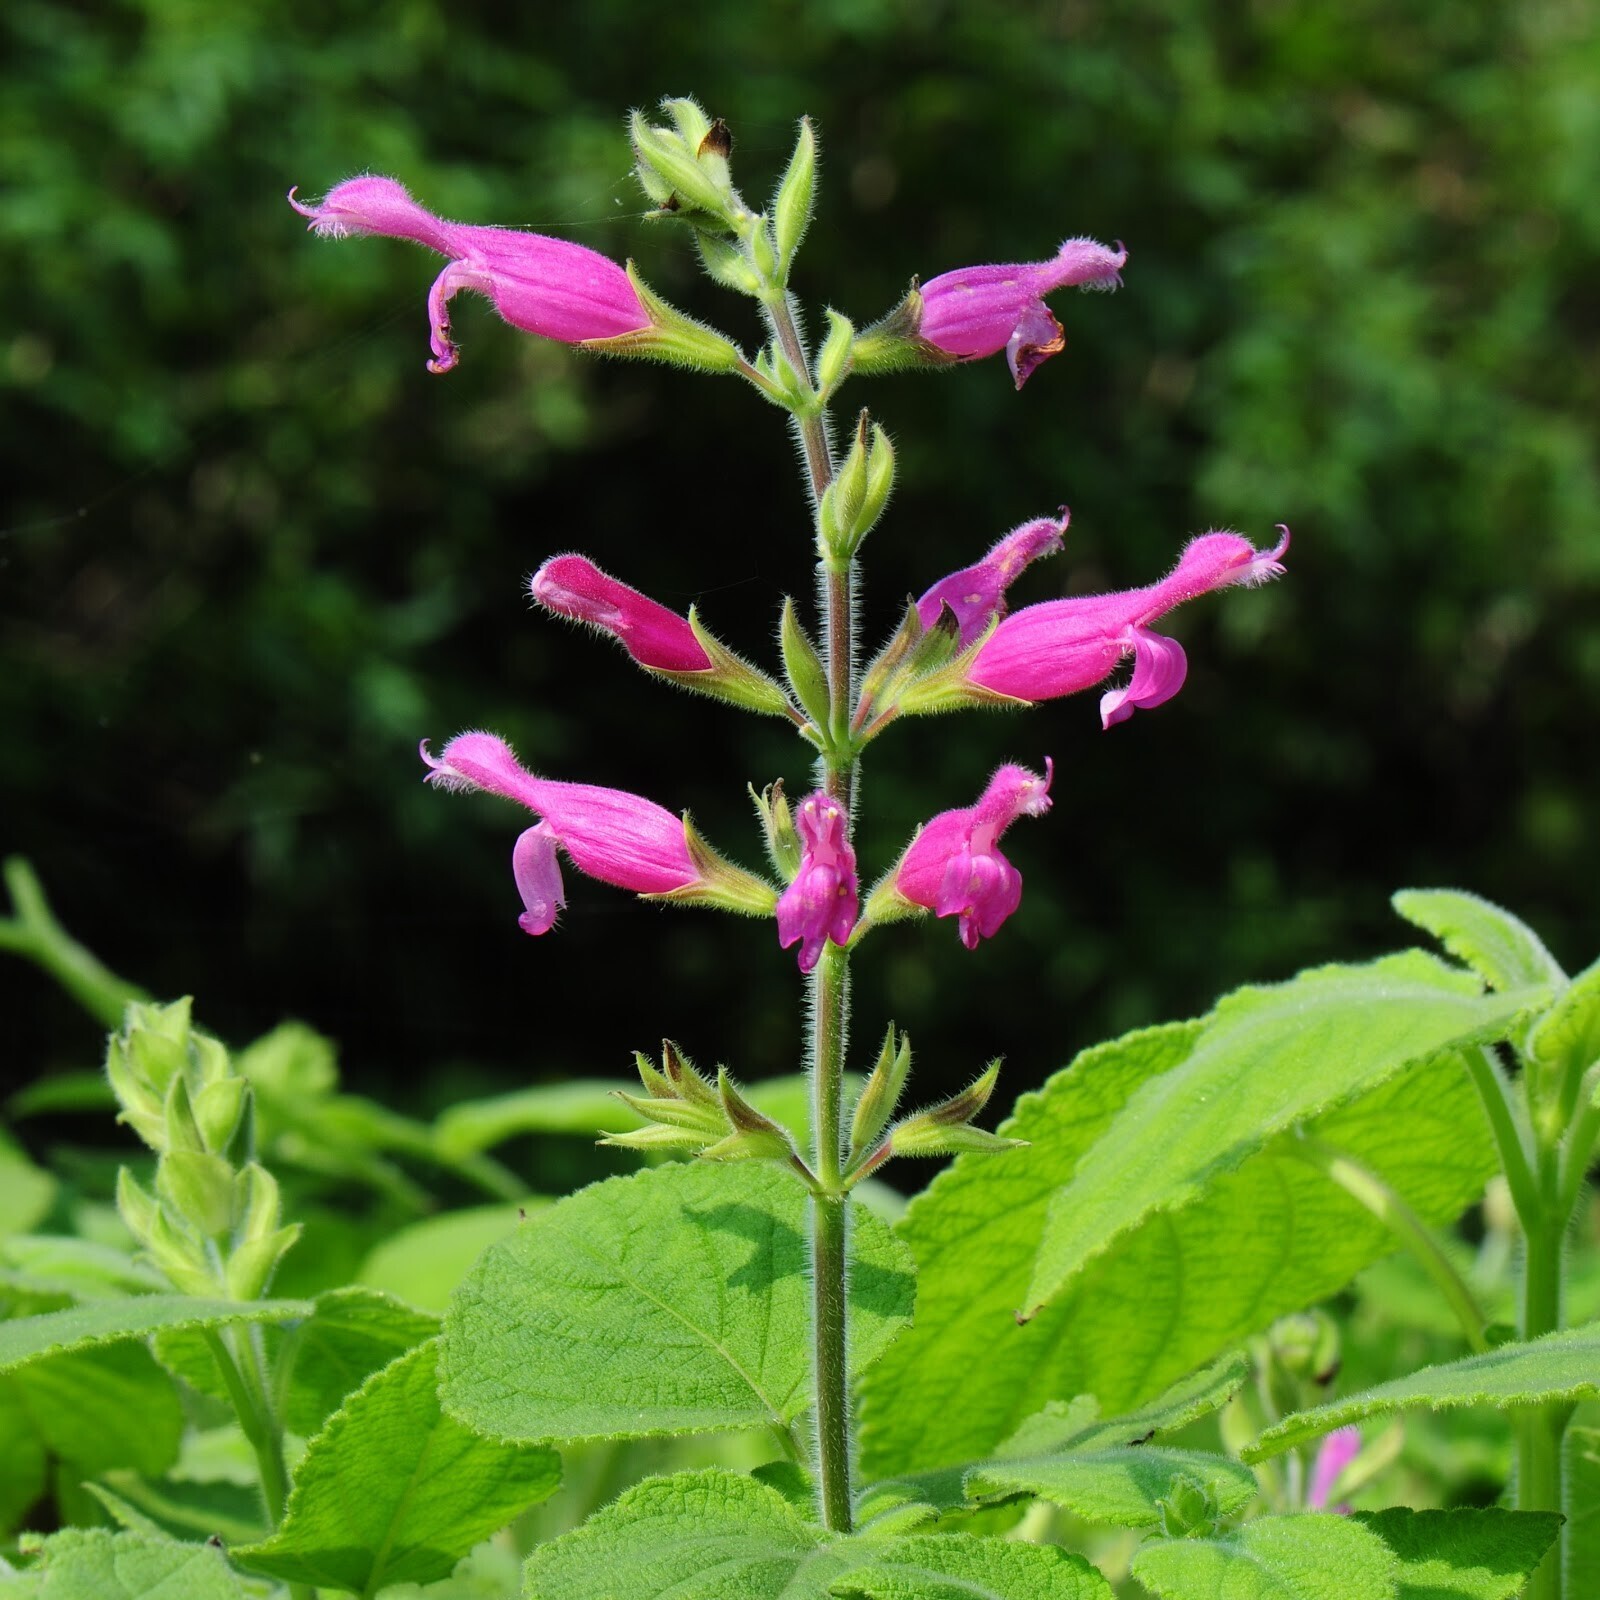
left=0, top=99, right=1600, bottom=1600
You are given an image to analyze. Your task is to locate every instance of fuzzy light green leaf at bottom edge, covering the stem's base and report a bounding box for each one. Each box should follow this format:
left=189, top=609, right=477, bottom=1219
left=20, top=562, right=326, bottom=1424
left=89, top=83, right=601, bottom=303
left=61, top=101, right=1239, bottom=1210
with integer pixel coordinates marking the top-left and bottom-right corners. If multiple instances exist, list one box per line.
left=523, top=1469, right=1110, bottom=1600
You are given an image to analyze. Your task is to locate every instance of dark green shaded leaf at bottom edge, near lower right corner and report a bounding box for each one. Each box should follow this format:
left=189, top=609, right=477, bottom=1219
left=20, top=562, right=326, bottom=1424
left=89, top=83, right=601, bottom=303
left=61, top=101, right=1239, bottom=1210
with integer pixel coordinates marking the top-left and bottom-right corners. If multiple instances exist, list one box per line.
left=1352, top=1506, right=1561, bottom=1600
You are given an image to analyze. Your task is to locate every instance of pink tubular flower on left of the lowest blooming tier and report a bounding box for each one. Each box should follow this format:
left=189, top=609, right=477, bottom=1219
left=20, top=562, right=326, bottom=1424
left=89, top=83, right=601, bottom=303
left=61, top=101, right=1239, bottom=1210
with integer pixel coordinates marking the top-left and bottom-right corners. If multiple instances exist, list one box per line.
left=422, top=733, right=701, bottom=933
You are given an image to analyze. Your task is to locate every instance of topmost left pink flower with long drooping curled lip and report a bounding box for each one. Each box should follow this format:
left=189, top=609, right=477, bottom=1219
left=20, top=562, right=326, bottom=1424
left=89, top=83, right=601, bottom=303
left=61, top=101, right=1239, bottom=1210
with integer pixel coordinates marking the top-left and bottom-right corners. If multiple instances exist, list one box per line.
left=290, top=178, right=650, bottom=373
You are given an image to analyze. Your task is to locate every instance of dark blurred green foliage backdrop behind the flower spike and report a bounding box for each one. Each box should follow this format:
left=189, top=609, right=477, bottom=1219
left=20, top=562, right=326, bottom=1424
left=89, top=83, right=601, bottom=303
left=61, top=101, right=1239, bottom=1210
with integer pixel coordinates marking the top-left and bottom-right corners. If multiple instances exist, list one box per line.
left=0, top=0, right=1600, bottom=1126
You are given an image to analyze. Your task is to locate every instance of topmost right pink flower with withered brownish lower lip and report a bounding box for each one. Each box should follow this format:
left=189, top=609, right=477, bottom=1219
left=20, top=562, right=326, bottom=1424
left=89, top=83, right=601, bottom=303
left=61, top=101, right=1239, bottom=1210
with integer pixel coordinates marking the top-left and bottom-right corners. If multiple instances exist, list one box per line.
left=917, top=238, right=1128, bottom=389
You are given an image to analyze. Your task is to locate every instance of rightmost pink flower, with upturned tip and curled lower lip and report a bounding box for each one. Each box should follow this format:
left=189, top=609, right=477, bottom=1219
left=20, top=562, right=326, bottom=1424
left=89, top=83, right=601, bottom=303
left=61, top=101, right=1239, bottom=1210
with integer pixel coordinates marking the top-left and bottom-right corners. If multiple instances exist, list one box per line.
left=966, top=526, right=1290, bottom=728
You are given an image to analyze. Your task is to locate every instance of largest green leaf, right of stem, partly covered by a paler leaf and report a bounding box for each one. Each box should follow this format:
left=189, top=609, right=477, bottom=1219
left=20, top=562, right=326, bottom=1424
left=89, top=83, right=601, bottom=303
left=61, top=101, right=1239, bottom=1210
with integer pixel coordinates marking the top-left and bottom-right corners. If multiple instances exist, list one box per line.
left=862, top=1022, right=1496, bottom=1477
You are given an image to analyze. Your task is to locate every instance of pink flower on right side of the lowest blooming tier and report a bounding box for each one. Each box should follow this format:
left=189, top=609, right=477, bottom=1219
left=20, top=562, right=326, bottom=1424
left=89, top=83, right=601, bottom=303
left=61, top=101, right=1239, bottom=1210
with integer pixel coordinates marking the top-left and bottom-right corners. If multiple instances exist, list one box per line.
left=894, top=757, right=1054, bottom=950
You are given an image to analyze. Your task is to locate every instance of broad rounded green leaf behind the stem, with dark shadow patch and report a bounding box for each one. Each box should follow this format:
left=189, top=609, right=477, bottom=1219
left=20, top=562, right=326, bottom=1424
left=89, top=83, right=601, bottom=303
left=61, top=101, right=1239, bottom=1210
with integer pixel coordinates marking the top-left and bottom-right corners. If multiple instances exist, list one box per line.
left=443, top=1163, right=912, bottom=1440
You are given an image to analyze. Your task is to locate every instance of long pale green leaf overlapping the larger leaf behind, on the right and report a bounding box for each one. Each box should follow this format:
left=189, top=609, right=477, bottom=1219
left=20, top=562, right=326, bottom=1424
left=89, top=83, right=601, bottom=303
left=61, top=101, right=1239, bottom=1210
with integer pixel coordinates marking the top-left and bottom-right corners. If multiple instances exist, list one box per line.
left=1027, top=950, right=1533, bottom=1307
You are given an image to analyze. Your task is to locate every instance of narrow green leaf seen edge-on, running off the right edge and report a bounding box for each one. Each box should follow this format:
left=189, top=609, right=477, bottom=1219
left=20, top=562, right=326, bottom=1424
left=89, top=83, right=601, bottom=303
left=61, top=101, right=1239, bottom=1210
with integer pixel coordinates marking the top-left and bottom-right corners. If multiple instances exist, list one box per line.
left=1242, top=1323, right=1600, bottom=1461
